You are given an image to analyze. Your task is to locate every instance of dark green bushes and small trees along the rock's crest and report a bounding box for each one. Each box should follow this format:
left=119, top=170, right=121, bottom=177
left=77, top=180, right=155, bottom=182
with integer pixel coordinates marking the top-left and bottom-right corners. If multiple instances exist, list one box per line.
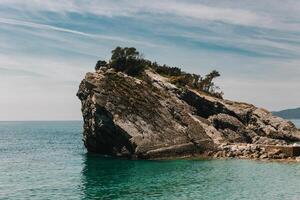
left=95, top=47, right=223, bottom=98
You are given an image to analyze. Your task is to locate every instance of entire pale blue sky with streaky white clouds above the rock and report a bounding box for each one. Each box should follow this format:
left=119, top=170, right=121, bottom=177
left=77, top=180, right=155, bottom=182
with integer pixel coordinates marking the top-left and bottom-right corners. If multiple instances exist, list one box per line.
left=0, top=0, right=300, bottom=121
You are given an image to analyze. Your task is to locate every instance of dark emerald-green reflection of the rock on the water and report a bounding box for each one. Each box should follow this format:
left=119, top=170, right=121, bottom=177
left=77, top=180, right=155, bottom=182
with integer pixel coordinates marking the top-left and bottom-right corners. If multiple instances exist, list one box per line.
left=82, top=154, right=210, bottom=199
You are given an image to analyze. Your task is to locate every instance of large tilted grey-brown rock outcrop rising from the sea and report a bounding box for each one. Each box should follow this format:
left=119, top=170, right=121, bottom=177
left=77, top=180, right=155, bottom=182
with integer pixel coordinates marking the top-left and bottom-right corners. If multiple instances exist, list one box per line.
left=77, top=68, right=300, bottom=159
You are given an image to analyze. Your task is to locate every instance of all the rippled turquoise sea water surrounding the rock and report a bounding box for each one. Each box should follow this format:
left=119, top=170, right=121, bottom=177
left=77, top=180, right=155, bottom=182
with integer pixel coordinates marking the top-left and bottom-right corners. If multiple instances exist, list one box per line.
left=0, top=121, right=300, bottom=200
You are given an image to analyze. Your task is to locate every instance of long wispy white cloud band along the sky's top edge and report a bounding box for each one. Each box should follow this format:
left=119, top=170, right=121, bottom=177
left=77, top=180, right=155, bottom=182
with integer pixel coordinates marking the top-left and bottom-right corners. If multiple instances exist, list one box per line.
left=1, top=0, right=299, bottom=30
